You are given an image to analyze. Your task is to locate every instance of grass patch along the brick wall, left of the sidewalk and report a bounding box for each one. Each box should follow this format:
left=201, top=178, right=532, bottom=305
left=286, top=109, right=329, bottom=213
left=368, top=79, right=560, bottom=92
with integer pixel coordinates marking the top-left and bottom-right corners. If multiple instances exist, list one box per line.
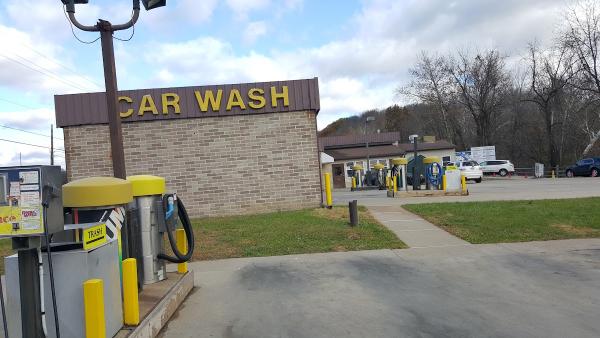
left=192, top=207, right=406, bottom=260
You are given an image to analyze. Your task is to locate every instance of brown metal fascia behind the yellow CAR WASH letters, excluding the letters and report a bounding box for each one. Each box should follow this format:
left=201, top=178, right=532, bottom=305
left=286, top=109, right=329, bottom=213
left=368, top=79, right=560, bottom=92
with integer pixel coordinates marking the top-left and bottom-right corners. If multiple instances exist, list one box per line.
left=54, top=77, right=321, bottom=127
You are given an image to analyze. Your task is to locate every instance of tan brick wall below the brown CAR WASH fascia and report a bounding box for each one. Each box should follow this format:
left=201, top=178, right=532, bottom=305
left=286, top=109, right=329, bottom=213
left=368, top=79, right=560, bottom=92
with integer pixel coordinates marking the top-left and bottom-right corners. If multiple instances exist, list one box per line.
left=64, top=112, right=321, bottom=217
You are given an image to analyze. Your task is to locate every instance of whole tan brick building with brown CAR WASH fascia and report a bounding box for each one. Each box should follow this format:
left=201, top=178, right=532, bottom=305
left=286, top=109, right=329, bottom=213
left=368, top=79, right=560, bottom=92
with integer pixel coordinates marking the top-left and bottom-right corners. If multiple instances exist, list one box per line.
left=55, top=78, right=321, bottom=217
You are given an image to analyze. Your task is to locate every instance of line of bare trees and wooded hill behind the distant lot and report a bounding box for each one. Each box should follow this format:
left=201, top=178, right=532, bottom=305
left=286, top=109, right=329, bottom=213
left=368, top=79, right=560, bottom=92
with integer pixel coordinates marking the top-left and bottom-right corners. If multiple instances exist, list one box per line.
left=321, top=0, right=600, bottom=167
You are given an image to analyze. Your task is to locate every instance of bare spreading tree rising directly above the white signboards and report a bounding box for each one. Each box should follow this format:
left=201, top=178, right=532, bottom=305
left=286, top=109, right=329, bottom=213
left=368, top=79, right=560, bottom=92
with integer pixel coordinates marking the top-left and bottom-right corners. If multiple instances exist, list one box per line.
left=447, top=50, right=511, bottom=145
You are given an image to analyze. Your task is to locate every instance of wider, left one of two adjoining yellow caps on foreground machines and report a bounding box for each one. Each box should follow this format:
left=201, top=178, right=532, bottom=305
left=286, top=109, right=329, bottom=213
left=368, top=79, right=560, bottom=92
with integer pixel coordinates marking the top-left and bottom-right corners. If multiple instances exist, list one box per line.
left=63, top=177, right=133, bottom=208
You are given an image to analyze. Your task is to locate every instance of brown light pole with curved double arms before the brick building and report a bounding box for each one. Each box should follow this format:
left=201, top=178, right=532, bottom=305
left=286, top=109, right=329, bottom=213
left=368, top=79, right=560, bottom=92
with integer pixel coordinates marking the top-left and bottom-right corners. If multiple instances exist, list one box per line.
left=61, top=0, right=167, bottom=179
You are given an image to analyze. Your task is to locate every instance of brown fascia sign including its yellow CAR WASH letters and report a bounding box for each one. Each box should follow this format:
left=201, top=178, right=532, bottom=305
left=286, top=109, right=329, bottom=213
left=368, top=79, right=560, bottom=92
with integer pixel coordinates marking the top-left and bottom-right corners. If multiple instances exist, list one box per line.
left=54, top=78, right=320, bottom=127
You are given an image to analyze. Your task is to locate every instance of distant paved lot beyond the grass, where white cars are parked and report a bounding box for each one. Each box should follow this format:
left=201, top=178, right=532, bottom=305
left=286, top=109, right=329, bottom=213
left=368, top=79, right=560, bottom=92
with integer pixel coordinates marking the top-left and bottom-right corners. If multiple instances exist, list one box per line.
left=333, top=177, right=600, bottom=206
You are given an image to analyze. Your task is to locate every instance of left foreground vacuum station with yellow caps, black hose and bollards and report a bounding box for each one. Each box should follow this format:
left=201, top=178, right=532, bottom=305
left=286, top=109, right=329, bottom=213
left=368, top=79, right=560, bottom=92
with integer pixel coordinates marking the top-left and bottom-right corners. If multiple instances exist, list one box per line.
left=0, top=166, right=194, bottom=338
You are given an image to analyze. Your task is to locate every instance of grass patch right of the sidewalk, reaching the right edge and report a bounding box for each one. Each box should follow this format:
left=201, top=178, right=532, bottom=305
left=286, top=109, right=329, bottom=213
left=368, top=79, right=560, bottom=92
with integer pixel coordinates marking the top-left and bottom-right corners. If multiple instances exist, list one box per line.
left=404, top=198, right=600, bottom=243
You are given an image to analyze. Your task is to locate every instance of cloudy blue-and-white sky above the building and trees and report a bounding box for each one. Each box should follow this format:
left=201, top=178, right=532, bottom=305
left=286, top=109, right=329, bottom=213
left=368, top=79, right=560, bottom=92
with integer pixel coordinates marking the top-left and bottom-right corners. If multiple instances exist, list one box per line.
left=0, top=0, right=567, bottom=166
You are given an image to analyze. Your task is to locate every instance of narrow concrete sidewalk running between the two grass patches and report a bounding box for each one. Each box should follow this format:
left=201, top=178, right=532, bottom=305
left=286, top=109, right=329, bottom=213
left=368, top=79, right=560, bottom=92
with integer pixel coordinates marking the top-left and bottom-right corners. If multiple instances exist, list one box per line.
left=368, top=205, right=471, bottom=248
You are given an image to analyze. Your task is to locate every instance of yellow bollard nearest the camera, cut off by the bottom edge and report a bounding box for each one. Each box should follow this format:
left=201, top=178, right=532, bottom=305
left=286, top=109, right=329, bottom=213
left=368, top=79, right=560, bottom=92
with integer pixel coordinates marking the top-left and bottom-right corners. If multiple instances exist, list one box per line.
left=83, top=279, right=106, bottom=338
